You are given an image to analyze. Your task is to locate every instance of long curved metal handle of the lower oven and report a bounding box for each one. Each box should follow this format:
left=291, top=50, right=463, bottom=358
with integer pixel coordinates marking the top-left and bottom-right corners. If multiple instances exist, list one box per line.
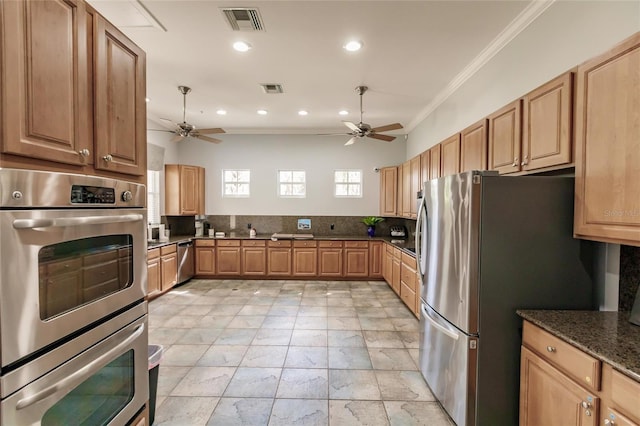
left=16, top=324, right=145, bottom=410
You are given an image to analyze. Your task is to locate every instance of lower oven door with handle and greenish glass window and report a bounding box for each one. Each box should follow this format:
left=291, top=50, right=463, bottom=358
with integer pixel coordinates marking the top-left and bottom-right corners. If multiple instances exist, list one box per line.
left=1, top=315, right=149, bottom=426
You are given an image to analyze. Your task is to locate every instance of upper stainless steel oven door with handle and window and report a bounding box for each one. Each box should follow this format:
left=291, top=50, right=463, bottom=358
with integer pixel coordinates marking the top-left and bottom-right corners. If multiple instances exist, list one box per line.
left=0, top=209, right=146, bottom=367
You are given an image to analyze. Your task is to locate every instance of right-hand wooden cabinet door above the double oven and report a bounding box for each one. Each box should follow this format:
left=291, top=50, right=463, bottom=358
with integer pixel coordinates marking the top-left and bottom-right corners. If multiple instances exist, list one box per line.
left=93, top=14, right=147, bottom=176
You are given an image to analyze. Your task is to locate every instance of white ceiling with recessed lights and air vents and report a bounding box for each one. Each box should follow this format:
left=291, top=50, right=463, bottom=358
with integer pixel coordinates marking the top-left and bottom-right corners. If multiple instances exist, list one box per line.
left=89, top=0, right=530, bottom=139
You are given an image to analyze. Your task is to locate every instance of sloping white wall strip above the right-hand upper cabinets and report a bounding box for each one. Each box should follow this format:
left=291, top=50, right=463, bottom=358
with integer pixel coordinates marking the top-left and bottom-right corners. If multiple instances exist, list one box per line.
left=406, top=0, right=640, bottom=159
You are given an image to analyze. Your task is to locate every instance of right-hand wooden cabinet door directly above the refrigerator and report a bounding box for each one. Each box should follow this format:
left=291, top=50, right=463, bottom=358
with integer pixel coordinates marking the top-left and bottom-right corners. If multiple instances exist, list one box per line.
left=520, top=72, right=573, bottom=170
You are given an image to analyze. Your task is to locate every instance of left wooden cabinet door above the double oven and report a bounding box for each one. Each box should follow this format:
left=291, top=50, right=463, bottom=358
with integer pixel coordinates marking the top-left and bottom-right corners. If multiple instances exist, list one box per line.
left=0, top=0, right=91, bottom=166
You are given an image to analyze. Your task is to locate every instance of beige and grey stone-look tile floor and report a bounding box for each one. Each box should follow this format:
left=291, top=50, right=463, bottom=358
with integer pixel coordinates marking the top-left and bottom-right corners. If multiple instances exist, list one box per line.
left=149, top=280, right=453, bottom=426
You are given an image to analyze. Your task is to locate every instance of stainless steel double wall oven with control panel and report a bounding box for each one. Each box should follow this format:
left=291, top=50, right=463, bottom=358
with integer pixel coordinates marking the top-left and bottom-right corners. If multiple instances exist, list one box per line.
left=0, top=169, right=149, bottom=425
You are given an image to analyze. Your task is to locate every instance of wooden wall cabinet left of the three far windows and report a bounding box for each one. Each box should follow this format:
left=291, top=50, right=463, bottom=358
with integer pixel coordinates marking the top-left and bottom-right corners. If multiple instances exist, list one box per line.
left=164, top=164, right=205, bottom=216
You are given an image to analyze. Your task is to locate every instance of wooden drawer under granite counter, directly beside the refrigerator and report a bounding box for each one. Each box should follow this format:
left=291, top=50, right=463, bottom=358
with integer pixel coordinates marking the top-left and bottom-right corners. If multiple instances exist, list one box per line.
left=522, top=321, right=602, bottom=391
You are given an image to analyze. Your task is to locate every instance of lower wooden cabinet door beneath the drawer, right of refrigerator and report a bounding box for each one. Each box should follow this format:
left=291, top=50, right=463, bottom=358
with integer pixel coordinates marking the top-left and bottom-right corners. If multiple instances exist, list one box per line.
left=520, top=346, right=600, bottom=426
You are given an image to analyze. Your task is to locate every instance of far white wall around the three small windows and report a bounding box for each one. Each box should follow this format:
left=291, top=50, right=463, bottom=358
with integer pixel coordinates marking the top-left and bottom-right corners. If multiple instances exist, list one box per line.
left=149, top=131, right=406, bottom=216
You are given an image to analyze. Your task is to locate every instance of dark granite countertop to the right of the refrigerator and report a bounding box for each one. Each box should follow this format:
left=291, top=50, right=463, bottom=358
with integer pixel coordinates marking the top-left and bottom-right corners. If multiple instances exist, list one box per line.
left=517, top=310, right=640, bottom=382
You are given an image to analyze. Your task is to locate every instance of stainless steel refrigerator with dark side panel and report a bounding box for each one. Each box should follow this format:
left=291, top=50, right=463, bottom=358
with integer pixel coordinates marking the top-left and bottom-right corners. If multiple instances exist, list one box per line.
left=416, top=171, right=593, bottom=426
